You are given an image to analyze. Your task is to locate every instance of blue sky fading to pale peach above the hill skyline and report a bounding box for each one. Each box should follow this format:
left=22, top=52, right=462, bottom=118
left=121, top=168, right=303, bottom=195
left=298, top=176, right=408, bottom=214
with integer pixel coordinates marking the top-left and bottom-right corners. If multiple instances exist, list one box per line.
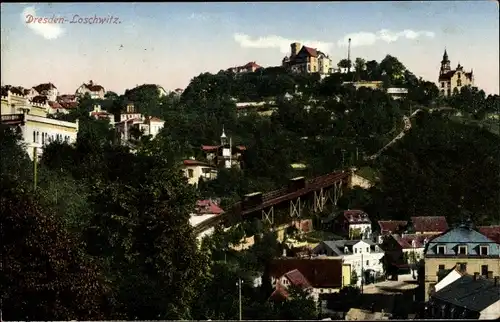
left=1, top=1, right=499, bottom=93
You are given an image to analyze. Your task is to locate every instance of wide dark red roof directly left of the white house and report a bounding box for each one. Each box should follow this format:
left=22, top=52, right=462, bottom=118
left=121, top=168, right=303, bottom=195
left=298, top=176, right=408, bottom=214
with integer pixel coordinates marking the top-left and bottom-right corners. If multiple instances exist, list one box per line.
left=270, top=258, right=342, bottom=288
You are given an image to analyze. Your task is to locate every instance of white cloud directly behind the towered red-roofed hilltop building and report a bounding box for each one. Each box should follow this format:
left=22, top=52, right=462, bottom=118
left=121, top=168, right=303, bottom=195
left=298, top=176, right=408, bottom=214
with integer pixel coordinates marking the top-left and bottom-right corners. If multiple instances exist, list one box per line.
left=233, top=34, right=334, bottom=54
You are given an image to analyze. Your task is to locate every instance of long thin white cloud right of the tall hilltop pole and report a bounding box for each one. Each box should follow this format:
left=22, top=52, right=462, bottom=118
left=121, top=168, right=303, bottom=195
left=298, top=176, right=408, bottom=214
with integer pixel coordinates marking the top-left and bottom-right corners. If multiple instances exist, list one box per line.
left=337, top=29, right=434, bottom=47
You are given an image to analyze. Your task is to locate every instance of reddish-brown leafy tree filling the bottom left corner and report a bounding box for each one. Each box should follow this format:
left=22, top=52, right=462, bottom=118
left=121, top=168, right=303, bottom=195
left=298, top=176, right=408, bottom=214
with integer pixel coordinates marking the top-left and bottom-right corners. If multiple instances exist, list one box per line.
left=0, top=178, right=112, bottom=320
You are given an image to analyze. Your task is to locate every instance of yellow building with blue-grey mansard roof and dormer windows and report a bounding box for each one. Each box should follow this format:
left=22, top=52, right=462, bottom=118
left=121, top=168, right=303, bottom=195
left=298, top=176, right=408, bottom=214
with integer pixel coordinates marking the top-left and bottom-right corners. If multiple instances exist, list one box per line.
left=424, top=224, right=500, bottom=301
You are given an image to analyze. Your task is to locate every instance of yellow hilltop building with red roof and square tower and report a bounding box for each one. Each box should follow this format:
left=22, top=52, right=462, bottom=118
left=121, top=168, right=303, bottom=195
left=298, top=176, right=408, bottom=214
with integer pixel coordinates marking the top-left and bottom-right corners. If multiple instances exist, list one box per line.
left=282, top=42, right=332, bottom=75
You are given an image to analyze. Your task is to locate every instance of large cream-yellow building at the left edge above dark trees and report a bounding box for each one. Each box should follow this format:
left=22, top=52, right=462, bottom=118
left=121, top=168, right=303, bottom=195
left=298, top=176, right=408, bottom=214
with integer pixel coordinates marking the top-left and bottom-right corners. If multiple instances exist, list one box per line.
left=1, top=91, right=78, bottom=158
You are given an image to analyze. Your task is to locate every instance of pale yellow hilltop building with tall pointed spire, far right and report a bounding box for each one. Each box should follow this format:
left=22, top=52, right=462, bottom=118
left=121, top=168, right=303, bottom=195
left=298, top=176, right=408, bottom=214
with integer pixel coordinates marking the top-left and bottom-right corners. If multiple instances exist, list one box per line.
left=438, top=49, right=474, bottom=96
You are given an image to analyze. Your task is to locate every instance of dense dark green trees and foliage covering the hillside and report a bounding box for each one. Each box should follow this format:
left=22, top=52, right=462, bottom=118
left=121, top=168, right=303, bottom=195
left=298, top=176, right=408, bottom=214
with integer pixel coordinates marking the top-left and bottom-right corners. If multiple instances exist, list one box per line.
left=0, top=56, right=500, bottom=320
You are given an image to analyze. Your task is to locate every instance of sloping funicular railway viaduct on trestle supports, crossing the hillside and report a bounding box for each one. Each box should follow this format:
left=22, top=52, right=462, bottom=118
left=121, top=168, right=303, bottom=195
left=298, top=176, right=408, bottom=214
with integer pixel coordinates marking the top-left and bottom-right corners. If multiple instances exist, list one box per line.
left=194, top=171, right=351, bottom=234
